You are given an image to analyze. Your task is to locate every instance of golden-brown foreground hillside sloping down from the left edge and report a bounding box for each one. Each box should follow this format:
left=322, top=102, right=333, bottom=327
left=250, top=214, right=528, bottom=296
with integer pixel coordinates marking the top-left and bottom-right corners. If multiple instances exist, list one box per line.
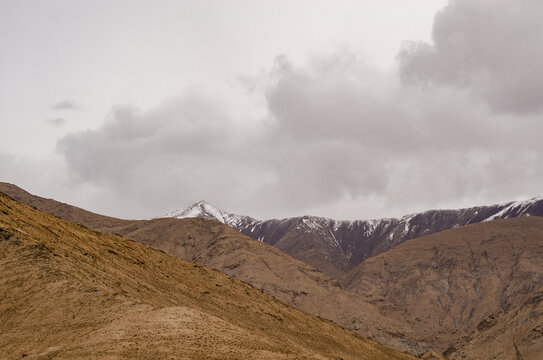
left=0, top=194, right=412, bottom=359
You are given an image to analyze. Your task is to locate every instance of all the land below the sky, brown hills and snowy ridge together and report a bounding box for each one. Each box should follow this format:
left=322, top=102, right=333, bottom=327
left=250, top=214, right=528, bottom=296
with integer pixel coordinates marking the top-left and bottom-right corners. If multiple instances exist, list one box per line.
left=0, top=183, right=543, bottom=360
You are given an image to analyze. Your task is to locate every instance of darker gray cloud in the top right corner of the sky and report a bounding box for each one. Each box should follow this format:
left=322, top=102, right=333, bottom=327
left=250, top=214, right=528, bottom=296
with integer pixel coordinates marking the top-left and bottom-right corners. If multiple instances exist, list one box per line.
left=399, top=0, right=543, bottom=114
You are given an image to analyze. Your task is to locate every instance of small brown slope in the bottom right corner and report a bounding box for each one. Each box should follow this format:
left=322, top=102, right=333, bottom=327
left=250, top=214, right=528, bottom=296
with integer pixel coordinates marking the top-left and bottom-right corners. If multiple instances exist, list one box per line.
left=445, top=289, right=543, bottom=360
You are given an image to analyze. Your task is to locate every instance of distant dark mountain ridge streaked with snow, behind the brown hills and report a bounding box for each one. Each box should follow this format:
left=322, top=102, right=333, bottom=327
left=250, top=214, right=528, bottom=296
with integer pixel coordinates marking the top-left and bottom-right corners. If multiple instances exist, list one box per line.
left=165, top=198, right=543, bottom=278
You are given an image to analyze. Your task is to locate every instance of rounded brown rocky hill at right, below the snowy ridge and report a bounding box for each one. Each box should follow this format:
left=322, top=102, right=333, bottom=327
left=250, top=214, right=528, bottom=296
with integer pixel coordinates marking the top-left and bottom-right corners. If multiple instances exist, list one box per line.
left=344, top=217, right=543, bottom=351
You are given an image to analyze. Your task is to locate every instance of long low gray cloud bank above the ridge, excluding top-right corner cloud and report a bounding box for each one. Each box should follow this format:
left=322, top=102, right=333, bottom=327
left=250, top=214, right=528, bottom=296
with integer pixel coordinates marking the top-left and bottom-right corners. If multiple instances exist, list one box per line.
left=58, top=46, right=543, bottom=218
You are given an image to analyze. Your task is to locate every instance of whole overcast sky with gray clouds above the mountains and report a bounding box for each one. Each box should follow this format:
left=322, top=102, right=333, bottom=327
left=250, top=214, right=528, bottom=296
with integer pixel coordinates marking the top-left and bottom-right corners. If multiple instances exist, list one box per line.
left=0, top=0, right=543, bottom=219
